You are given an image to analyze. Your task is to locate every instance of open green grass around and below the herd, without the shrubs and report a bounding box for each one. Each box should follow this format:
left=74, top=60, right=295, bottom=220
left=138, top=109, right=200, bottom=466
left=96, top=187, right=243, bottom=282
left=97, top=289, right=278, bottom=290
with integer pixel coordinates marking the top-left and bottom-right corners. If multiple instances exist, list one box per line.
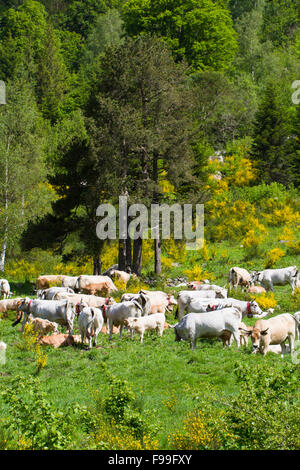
left=0, top=237, right=300, bottom=449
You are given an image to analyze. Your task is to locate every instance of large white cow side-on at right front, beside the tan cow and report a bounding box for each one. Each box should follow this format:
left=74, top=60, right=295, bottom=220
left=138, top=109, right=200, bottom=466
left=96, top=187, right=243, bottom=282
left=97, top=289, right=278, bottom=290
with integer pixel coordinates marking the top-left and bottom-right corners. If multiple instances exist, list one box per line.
left=173, top=307, right=242, bottom=349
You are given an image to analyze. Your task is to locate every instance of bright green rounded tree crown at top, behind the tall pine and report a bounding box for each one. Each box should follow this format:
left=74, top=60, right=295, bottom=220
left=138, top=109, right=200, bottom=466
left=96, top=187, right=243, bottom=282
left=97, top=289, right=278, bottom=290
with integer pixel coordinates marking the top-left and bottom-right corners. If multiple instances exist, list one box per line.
left=123, top=0, right=236, bottom=70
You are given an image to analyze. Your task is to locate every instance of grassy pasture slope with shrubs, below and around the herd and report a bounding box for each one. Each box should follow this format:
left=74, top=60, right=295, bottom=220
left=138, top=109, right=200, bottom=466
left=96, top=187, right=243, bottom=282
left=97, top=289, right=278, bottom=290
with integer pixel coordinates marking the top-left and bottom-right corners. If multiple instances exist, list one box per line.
left=0, top=243, right=300, bottom=450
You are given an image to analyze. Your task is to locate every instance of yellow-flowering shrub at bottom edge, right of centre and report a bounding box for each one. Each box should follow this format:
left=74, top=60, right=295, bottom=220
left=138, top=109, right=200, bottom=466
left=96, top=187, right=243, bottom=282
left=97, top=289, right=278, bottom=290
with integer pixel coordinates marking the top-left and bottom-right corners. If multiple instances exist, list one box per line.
left=169, top=411, right=215, bottom=450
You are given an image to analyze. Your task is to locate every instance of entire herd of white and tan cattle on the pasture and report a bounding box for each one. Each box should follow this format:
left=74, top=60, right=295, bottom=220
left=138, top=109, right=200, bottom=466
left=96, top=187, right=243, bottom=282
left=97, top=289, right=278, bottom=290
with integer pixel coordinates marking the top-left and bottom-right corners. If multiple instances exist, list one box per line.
left=0, top=266, right=300, bottom=354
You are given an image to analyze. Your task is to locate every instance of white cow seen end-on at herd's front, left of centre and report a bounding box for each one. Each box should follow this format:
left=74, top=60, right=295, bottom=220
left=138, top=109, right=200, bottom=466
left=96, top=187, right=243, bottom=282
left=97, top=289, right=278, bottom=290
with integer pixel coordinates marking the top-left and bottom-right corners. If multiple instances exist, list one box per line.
left=78, top=303, right=104, bottom=349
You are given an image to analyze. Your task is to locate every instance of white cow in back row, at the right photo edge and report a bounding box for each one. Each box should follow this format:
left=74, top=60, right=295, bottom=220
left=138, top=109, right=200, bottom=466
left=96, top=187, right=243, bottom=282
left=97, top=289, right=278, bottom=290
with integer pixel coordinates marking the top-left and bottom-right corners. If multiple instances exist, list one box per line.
left=251, top=266, right=299, bottom=292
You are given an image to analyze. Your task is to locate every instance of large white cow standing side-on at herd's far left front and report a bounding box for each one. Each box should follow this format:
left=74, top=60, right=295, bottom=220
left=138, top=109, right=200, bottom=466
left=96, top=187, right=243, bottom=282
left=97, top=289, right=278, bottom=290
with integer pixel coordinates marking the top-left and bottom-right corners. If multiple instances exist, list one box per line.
left=12, top=297, right=75, bottom=334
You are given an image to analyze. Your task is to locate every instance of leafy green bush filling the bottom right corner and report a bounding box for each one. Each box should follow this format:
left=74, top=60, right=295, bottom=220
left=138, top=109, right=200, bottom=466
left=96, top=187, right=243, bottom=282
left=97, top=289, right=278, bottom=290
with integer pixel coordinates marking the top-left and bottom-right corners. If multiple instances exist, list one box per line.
left=221, top=363, right=300, bottom=450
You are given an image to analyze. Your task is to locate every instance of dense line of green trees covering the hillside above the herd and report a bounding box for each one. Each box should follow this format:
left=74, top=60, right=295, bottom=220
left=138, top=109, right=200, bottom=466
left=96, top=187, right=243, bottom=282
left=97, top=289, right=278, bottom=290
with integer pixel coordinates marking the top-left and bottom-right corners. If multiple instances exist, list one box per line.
left=0, top=0, right=300, bottom=274
